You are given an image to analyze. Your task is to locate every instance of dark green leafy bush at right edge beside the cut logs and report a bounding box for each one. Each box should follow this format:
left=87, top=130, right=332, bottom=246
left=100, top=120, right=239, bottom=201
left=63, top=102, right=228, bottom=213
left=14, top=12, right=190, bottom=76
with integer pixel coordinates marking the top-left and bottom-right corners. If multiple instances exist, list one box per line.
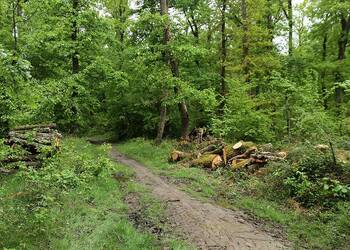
left=265, top=145, right=350, bottom=207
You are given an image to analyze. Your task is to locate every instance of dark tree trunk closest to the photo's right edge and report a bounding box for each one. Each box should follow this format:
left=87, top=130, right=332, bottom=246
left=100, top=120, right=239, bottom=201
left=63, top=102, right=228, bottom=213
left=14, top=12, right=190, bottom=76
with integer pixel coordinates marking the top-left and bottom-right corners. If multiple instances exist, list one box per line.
left=335, top=16, right=350, bottom=105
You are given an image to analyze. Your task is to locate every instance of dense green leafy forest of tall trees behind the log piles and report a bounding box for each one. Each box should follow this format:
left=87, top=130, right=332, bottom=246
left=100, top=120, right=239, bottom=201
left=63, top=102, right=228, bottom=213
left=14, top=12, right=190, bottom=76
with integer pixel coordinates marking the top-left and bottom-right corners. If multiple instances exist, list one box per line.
left=0, top=0, right=350, bottom=141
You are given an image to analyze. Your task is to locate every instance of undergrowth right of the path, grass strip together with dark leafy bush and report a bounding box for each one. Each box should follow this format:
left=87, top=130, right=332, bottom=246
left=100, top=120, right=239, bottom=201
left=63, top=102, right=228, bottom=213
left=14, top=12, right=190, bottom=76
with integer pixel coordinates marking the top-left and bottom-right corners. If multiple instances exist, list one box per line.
left=118, top=139, right=350, bottom=249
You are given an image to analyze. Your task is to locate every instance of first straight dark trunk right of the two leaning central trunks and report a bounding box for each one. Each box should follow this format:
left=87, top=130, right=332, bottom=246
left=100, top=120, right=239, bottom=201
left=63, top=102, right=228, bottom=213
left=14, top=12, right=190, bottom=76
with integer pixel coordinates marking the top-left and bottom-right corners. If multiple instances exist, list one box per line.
left=220, top=0, right=227, bottom=110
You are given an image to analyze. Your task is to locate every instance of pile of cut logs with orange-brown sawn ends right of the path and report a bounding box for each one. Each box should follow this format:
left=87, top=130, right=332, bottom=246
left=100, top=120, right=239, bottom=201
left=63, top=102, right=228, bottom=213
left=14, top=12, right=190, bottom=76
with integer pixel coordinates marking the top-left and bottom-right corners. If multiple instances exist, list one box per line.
left=169, top=141, right=287, bottom=173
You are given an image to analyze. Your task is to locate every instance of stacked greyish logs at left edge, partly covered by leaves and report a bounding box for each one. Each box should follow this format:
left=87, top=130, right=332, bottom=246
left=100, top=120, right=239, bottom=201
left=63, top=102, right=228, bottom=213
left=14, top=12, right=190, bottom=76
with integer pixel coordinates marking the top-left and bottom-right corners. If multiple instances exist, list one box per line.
left=0, top=124, right=62, bottom=174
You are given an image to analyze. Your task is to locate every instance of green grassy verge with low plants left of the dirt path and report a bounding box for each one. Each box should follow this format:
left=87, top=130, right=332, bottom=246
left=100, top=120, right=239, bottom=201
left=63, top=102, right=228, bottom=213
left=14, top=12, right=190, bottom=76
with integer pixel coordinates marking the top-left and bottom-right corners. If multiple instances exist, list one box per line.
left=0, top=139, right=188, bottom=250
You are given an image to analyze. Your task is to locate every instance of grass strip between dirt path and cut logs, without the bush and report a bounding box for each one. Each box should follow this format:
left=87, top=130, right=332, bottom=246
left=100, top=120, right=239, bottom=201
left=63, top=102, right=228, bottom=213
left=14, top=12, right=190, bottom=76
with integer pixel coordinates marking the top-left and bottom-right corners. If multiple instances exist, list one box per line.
left=118, top=139, right=350, bottom=249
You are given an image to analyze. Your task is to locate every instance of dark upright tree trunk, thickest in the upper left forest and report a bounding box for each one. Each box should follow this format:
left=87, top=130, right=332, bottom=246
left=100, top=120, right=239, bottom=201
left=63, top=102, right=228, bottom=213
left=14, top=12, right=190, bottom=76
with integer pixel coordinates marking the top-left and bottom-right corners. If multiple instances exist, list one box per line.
left=71, top=0, right=79, bottom=74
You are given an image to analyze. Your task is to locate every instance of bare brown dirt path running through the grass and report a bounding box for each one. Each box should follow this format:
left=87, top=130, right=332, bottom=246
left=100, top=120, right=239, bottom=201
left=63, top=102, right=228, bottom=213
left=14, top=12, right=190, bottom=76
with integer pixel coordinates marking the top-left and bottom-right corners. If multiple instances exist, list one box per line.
left=111, top=148, right=288, bottom=250
